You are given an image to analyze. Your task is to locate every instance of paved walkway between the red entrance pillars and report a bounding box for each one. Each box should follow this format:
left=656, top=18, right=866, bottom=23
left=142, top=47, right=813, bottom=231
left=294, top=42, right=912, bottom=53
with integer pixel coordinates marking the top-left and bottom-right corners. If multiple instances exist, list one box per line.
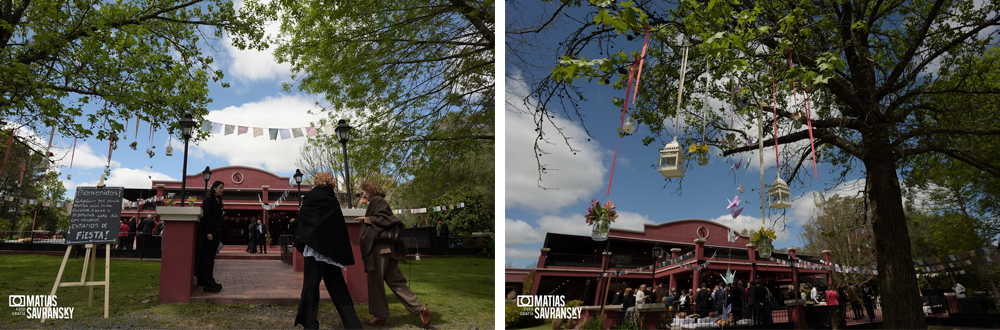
left=191, top=245, right=331, bottom=306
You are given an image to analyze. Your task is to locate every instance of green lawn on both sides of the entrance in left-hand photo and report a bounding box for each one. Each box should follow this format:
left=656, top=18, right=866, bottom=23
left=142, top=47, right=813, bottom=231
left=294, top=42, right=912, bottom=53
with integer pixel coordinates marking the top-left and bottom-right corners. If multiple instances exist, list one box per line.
left=0, top=254, right=496, bottom=329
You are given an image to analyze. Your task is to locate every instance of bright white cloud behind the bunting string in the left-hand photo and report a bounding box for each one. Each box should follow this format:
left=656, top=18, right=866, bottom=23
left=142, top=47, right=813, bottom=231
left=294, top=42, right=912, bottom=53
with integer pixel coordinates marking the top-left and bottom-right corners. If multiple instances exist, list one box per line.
left=197, top=96, right=324, bottom=172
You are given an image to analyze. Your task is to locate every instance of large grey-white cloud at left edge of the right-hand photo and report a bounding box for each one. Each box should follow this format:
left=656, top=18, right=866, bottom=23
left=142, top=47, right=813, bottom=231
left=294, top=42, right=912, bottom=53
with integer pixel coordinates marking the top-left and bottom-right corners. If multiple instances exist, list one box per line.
left=505, top=75, right=607, bottom=212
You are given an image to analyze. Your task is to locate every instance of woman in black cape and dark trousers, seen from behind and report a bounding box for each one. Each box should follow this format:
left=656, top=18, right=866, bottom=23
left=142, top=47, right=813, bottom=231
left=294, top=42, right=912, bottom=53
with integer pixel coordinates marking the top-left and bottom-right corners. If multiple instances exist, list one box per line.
left=292, top=172, right=361, bottom=329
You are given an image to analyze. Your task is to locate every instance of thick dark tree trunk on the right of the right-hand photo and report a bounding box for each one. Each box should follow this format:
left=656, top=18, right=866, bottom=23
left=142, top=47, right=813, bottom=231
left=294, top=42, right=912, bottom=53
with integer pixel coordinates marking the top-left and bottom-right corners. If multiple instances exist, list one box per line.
left=862, top=148, right=927, bottom=329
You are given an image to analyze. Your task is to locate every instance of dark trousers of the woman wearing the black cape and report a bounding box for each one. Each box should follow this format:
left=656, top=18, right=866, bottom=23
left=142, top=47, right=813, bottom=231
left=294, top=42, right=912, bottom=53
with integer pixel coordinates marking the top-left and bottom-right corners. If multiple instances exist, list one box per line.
left=294, top=257, right=361, bottom=329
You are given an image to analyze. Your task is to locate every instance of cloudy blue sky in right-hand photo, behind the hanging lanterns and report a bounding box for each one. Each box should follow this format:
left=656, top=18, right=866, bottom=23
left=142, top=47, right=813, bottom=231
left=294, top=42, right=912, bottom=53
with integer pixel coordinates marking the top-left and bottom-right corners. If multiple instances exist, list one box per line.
left=504, top=1, right=896, bottom=267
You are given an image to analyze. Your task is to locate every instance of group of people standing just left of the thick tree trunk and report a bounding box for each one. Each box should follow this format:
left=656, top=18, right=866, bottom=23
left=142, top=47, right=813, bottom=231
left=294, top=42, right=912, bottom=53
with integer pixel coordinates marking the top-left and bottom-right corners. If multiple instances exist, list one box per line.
left=801, top=283, right=875, bottom=325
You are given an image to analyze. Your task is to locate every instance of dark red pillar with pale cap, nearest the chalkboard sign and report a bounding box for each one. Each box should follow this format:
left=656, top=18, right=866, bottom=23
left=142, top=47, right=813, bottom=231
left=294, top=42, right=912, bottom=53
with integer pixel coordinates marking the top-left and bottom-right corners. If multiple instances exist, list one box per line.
left=157, top=206, right=202, bottom=304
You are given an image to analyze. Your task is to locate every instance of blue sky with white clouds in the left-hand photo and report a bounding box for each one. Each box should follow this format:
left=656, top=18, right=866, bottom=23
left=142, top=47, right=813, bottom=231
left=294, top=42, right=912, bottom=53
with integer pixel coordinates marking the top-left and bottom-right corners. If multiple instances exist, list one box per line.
left=12, top=5, right=326, bottom=198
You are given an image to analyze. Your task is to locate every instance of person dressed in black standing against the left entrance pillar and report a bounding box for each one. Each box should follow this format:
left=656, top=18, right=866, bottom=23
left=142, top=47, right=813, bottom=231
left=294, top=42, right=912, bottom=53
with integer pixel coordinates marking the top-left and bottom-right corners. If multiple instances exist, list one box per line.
left=194, top=181, right=226, bottom=292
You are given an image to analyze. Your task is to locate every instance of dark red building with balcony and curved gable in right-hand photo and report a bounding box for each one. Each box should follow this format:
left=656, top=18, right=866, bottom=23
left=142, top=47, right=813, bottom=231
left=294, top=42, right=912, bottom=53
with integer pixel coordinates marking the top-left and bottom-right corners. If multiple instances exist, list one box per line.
left=505, top=219, right=830, bottom=305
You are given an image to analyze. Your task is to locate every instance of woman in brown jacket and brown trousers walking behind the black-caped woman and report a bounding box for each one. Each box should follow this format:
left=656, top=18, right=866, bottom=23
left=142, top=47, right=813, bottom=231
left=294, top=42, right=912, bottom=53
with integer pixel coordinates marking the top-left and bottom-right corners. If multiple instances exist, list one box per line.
left=355, top=180, right=431, bottom=328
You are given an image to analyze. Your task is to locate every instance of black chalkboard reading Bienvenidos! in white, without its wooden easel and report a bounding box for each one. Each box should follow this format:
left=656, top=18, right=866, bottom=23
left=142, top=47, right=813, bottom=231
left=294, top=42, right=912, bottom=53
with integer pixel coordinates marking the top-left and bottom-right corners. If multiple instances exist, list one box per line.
left=66, top=187, right=122, bottom=245
